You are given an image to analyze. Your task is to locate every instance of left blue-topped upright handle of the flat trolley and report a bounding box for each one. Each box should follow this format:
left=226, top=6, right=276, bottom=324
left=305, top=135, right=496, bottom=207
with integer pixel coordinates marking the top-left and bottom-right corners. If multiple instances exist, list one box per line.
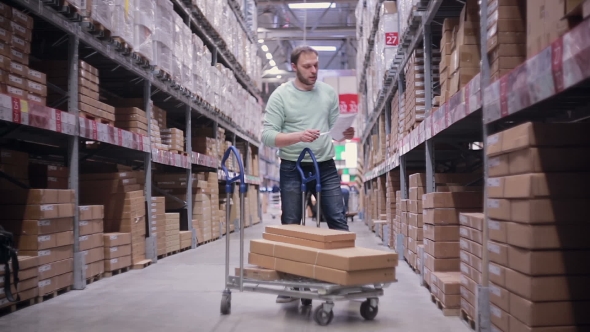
left=221, top=146, right=248, bottom=294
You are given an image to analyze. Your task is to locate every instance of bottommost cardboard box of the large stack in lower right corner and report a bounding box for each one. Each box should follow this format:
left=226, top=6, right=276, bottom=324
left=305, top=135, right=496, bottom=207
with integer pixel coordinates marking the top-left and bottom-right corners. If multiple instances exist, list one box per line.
left=510, top=293, right=590, bottom=331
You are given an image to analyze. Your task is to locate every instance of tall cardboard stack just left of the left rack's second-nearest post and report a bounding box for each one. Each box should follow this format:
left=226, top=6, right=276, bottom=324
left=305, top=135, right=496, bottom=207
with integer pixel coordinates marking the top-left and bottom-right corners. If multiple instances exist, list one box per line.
left=80, top=170, right=146, bottom=264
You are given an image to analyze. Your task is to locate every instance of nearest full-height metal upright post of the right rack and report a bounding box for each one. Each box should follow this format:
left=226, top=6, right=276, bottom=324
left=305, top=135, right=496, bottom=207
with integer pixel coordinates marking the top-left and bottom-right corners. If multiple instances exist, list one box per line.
left=475, top=0, right=491, bottom=332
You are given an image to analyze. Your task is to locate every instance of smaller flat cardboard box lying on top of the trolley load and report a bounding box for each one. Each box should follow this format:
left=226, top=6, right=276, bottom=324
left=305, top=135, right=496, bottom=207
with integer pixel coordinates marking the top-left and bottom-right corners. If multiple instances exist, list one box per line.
left=265, top=225, right=356, bottom=242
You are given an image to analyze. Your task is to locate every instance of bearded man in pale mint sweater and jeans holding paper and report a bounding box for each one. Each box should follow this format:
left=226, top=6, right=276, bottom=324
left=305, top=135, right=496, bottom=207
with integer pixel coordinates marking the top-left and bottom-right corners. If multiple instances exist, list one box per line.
left=262, top=46, right=354, bottom=303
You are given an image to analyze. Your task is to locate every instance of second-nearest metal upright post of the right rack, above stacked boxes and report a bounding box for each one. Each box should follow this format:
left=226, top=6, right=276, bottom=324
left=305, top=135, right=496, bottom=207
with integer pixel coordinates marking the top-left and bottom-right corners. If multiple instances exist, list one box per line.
left=423, top=23, right=436, bottom=193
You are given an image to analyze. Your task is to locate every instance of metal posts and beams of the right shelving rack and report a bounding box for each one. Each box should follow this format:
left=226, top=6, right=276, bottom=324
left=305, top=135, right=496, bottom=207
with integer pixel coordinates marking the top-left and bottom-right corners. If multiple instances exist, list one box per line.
left=359, top=0, right=590, bottom=331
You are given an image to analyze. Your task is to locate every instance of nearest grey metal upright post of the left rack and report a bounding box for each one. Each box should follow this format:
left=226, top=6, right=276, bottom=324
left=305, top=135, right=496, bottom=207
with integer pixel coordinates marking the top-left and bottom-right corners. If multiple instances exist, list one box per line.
left=68, top=35, right=86, bottom=290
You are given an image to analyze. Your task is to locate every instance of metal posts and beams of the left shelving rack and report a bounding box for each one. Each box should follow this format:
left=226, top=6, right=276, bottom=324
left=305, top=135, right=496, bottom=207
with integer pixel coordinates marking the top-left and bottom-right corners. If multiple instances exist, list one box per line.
left=0, top=0, right=261, bottom=289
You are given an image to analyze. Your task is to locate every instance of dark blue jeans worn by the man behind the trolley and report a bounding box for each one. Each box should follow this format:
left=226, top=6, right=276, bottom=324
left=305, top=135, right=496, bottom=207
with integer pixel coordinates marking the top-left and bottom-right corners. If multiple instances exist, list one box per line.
left=280, top=160, right=348, bottom=231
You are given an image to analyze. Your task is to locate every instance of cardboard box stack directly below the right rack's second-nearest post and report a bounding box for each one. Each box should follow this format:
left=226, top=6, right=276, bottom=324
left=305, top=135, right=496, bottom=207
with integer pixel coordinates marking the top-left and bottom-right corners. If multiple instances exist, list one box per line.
left=423, top=191, right=483, bottom=309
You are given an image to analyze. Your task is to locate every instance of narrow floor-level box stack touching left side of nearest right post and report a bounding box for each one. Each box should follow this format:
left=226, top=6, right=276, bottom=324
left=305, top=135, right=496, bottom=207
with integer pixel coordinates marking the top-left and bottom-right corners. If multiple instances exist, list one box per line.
left=459, top=213, right=491, bottom=320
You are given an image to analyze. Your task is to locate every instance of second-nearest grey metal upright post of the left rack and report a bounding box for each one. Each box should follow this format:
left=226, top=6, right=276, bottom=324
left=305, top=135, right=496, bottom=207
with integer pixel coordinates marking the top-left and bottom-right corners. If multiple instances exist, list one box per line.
left=143, top=80, right=158, bottom=263
